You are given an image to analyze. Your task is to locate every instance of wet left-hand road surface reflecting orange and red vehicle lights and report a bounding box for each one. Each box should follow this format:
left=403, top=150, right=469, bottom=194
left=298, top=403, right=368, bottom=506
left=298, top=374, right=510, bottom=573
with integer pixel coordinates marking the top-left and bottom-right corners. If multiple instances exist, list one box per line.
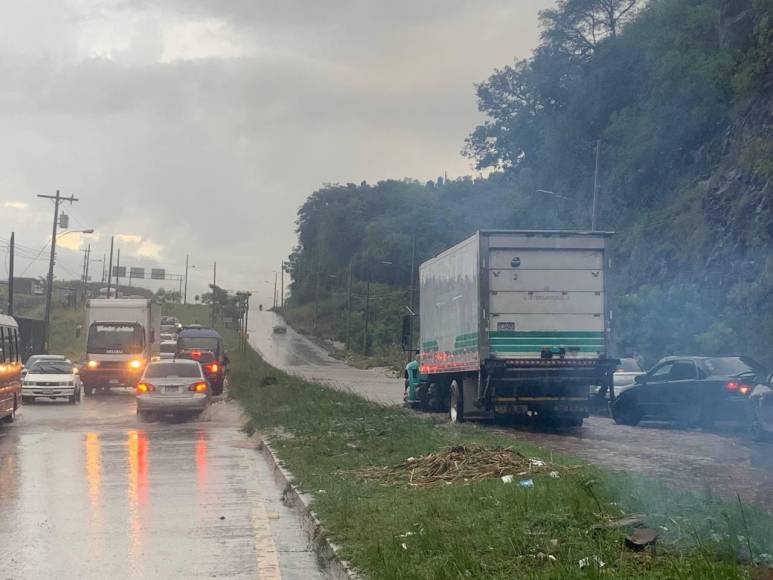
left=0, top=389, right=324, bottom=580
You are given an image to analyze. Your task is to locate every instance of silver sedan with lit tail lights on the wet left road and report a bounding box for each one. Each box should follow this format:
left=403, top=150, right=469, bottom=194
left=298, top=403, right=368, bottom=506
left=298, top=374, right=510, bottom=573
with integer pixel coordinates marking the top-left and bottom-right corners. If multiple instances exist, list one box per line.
left=136, top=359, right=212, bottom=419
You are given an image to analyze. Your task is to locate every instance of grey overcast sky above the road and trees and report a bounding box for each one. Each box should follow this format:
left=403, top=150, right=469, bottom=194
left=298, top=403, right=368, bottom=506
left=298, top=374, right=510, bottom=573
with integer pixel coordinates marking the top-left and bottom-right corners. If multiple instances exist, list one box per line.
left=0, top=0, right=552, bottom=302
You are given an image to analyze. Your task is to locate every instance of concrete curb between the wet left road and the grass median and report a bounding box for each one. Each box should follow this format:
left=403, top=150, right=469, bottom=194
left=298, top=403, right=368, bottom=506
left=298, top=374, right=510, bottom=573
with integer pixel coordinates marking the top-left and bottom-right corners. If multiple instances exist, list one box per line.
left=258, top=439, right=363, bottom=580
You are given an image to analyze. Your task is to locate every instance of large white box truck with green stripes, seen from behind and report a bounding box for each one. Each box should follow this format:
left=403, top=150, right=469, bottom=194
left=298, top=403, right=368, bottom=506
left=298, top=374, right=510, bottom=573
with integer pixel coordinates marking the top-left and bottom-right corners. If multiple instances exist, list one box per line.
left=405, top=230, right=617, bottom=426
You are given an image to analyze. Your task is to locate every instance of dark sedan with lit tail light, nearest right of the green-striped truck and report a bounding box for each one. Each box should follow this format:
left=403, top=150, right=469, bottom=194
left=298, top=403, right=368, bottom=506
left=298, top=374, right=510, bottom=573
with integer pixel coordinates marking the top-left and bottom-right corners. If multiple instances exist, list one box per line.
left=610, top=356, right=765, bottom=428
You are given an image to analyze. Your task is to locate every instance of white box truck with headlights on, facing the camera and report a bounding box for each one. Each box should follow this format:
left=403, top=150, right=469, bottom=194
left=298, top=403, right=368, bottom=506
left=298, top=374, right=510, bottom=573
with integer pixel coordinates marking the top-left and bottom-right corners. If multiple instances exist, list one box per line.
left=81, top=298, right=161, bottom=395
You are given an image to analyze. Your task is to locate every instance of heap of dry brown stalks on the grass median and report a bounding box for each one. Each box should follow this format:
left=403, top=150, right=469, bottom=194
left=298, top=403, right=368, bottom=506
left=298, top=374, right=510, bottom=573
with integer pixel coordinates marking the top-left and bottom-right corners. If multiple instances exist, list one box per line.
left=357, top=445, right=576, bottom=487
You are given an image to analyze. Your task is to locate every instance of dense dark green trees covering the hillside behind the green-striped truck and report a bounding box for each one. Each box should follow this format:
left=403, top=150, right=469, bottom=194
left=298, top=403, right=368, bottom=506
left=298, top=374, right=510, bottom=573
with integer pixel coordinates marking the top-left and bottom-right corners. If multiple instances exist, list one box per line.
left=290, top=0, right=773, bottom=363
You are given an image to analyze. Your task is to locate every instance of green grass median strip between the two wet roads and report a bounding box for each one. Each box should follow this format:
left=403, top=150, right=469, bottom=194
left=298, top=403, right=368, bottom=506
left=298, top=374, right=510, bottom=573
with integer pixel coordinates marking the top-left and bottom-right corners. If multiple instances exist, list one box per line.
left=226, top=332, right=773, bottom=579
